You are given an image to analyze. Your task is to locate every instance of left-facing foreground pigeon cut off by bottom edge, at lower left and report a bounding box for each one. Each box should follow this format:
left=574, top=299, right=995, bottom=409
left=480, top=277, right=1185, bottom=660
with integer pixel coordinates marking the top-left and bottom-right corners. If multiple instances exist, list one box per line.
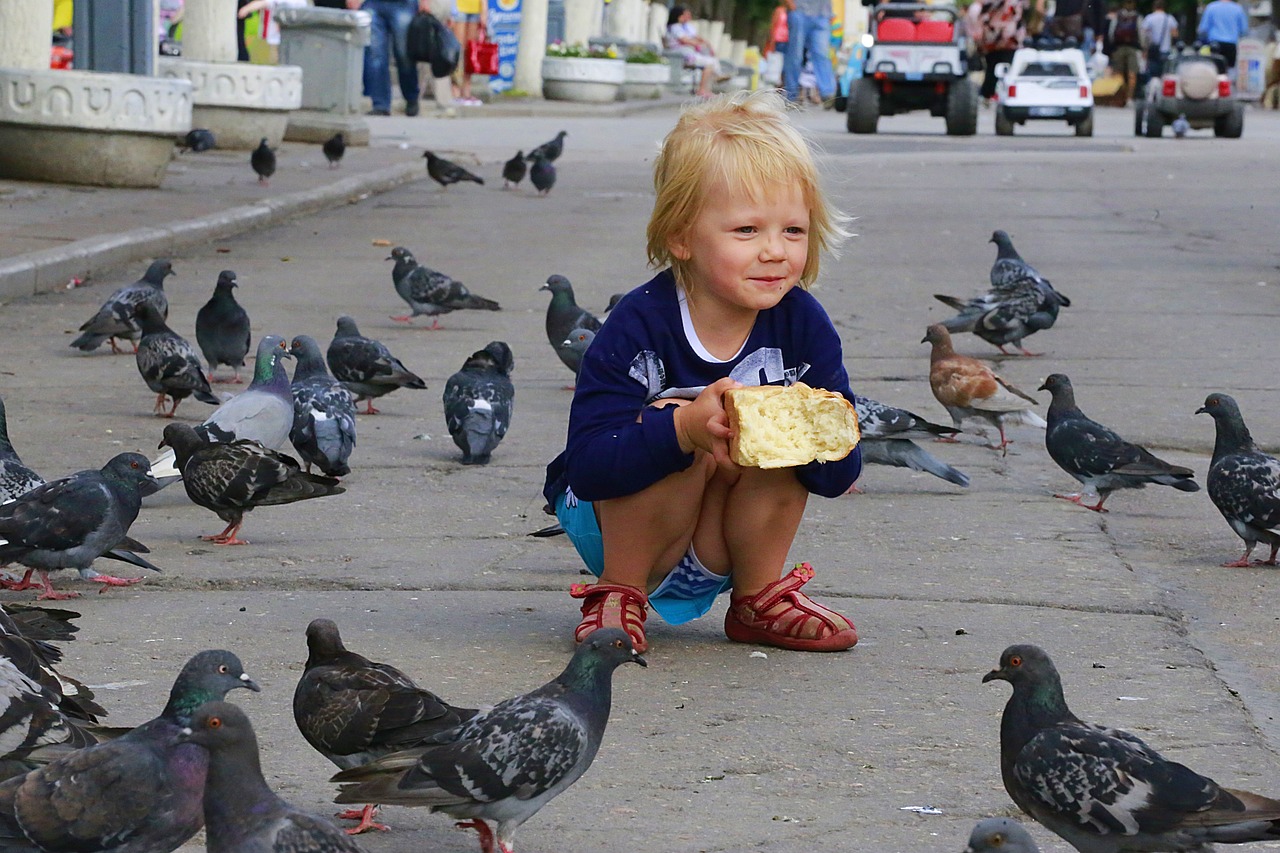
left=178, top=702, right=362, bottom=853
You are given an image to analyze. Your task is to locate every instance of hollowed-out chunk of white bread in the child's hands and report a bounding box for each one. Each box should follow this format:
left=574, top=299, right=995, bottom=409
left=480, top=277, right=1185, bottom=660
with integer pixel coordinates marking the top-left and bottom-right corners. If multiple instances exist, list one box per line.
left=724, top=382, right=859, bottom=467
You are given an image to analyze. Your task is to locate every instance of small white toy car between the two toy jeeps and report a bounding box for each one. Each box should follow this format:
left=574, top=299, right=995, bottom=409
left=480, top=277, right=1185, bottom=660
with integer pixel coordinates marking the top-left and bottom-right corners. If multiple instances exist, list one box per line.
left=996, top=47, right=1093, bottom=136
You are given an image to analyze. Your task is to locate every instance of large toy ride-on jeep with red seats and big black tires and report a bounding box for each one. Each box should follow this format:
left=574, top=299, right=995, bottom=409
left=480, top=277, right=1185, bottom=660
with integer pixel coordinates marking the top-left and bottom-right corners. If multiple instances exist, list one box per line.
left=845, top=3, right=978, bottom=136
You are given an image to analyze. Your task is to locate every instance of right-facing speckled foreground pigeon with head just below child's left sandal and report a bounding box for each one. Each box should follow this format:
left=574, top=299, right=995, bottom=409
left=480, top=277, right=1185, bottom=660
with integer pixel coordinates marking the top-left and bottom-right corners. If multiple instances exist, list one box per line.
left=333, top=628, right=648, bottom=853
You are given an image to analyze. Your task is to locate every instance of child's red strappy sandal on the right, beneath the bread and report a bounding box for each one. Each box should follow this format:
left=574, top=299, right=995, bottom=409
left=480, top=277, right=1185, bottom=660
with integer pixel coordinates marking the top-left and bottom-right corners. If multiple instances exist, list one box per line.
left=724, top=562, right=858, bottom=652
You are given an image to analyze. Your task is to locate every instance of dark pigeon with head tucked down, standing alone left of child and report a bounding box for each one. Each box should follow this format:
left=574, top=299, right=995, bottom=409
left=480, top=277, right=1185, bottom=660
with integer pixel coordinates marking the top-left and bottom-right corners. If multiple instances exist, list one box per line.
left=444, top=341, right=516, bottom=465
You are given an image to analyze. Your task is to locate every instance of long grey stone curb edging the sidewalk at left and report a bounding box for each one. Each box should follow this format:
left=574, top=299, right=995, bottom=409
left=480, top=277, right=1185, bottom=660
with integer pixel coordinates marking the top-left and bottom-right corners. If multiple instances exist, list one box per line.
left=0, top=161, right=426, bottom=298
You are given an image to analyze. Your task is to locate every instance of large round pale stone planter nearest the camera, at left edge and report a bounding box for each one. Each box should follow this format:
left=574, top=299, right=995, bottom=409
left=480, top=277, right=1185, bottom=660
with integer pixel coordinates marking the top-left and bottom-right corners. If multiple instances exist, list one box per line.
left=0, top=68, right=191, bottom=187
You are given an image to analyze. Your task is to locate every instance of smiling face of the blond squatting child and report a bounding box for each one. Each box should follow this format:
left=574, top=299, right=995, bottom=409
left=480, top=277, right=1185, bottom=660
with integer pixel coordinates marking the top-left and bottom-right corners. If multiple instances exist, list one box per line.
left=671, top=184, right=809, bottom=311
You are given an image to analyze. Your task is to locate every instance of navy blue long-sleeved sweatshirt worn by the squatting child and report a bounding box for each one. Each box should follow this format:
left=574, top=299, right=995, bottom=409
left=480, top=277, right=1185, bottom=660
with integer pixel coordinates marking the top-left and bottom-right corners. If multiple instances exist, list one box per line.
left=543, top=270, right=863, bottom=506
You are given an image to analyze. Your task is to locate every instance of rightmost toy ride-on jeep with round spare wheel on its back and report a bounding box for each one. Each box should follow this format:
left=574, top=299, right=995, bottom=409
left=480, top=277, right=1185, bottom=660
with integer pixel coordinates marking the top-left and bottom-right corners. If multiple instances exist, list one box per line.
left=1133, top=47, right=1244, bottom=140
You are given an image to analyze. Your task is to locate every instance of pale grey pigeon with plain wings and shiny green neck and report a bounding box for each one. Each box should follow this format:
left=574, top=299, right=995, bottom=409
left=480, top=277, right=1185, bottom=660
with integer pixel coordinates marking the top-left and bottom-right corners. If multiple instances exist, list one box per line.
left=151, top=334, right=293, bottom=485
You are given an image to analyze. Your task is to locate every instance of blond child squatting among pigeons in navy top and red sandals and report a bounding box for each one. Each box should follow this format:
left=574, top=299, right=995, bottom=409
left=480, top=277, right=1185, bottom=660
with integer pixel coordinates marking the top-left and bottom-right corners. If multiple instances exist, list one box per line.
left=544, top=91, right=861, bottom=652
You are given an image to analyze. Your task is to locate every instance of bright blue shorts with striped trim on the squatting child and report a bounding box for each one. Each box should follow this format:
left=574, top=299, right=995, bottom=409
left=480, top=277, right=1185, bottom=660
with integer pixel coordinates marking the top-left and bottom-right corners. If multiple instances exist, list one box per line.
left=556, top=492, right=733, bottom=625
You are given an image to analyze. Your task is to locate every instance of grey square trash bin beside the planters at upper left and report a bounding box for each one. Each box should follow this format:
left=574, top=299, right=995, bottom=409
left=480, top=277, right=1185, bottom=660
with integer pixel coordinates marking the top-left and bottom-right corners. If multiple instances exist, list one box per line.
left=275, top=6, right=372, bottom=115
